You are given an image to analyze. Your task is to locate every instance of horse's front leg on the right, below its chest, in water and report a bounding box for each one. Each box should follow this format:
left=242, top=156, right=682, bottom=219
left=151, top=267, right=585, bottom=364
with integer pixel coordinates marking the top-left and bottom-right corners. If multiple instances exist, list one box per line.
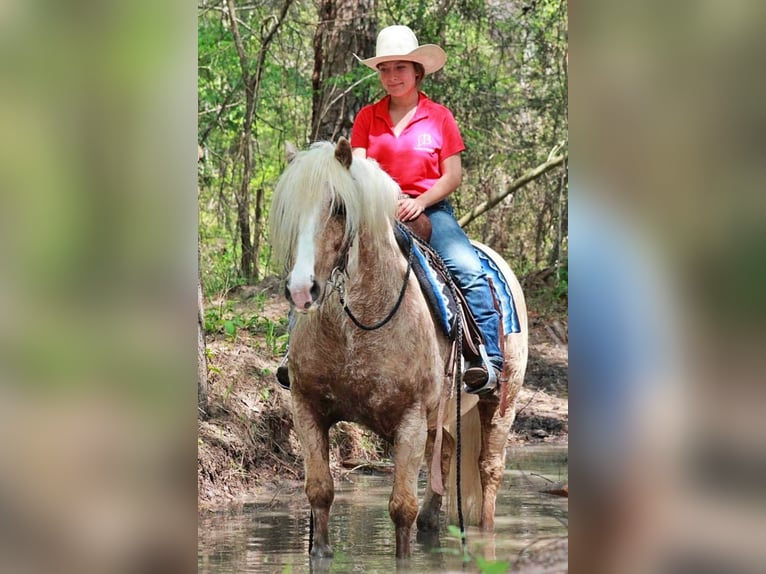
left=388, top=405, right=428, bottom=558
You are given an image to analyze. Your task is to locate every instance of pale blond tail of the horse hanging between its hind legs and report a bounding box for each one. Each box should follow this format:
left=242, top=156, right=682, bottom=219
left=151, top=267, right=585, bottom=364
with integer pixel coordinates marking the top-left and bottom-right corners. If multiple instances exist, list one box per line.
left=447, top=407, right=482, bottom=525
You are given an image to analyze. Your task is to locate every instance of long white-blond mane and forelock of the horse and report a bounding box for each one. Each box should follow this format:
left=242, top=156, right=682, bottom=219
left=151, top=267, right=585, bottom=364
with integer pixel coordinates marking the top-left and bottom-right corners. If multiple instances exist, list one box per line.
left=270, top=142, right=399, bottom=266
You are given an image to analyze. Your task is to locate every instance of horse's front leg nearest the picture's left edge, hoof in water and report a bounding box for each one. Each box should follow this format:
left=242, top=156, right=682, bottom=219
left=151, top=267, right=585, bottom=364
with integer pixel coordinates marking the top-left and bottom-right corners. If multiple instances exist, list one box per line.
left=293, top=395, right=335, bottom=558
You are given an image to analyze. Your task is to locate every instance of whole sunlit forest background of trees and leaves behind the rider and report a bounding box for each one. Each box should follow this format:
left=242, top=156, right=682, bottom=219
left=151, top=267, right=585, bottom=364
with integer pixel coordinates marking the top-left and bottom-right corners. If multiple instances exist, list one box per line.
left=198, top=0, right=568, bottom=296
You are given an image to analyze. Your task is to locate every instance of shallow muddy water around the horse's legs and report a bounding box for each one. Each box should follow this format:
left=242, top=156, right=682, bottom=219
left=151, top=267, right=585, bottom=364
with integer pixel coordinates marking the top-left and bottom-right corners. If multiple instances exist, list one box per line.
left=198, top=446, right=568, bottom=574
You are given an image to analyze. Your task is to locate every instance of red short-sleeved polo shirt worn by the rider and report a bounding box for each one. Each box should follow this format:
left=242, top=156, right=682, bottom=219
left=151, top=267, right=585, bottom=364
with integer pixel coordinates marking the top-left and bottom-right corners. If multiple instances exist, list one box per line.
left=351, top=92, right=465, bottom=196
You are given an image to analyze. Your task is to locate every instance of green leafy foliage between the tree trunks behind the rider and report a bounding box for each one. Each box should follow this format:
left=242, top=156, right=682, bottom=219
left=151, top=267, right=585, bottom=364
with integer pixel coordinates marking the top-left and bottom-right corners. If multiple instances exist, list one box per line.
left=198, top=0, right=568, bottom=286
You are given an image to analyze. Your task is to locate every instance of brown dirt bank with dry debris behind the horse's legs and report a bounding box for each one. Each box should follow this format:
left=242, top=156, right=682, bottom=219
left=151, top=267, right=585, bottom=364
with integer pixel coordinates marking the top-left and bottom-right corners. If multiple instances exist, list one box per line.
left=197, top=281, right=568, bottom=510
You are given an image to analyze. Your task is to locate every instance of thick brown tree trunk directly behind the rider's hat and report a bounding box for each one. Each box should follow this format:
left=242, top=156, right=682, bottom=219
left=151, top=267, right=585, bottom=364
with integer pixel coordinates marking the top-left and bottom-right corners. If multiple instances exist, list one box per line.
left=311, top=0, right=377, bottom=141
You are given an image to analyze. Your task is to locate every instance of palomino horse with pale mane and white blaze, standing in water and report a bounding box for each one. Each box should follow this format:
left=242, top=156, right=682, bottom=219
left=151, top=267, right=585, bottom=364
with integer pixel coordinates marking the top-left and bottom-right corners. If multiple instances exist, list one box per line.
left=271, top=139, right=527, bottom=557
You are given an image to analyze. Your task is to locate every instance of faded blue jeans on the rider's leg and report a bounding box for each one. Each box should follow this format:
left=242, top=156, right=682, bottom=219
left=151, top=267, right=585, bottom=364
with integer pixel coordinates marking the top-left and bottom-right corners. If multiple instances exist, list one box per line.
left=426, top=200, right=503, bottom=369
